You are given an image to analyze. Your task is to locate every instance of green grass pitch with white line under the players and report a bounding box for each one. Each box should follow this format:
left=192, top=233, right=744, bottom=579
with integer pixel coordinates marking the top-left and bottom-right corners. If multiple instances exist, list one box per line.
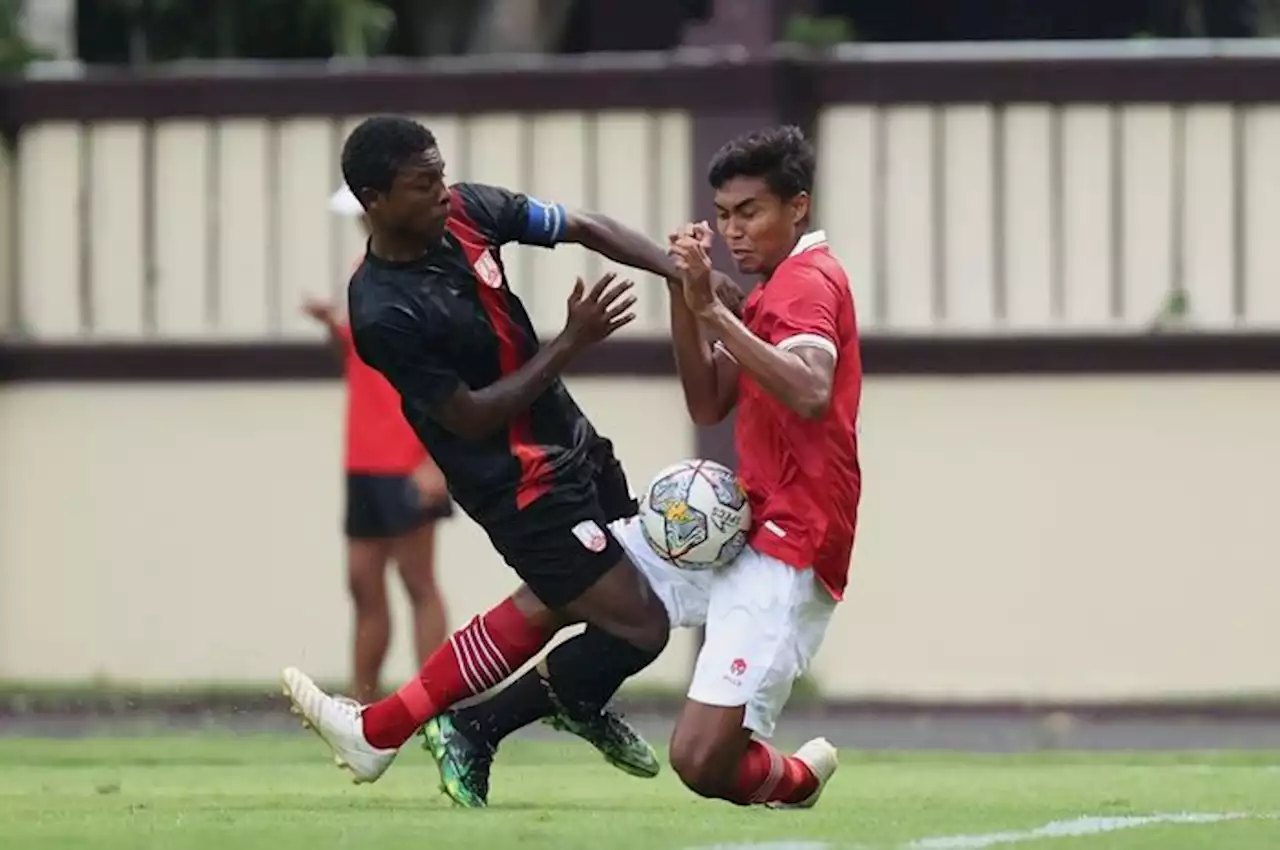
left=0, top=734, right=1280, bottom=850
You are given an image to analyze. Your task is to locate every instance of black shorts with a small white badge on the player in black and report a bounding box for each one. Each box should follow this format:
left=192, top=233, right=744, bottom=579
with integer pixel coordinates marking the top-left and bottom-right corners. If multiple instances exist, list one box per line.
left=489, top=492, right=626, bottom=608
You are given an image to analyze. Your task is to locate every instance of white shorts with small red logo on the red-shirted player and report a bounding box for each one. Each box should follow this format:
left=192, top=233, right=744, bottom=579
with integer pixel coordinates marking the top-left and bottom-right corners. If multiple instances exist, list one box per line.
left=609, top=518, right=836, bottom=737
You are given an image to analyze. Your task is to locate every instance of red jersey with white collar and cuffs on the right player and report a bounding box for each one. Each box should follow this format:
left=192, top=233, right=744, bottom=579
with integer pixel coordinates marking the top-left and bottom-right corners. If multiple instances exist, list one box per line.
left=733, top=230, right=863, bottom=599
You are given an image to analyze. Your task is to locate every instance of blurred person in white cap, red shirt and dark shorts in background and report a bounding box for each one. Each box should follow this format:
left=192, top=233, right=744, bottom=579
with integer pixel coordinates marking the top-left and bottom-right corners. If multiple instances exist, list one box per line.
left=303, top=187, right=453, bottom=703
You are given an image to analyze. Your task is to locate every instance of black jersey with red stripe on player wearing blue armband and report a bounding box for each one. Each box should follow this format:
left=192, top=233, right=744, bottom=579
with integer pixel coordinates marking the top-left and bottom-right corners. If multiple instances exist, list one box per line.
left=348, top=183, right=627, bottom=529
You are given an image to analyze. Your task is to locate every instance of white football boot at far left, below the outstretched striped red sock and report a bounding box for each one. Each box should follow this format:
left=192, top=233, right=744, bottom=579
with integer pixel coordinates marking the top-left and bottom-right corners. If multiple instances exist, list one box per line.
left=280, top=667, right=399, bottom=783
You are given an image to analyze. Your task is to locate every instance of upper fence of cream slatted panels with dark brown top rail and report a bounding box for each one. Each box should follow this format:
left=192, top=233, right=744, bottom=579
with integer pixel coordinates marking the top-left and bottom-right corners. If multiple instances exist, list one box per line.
left=0, top=49, right=1280, bottom=358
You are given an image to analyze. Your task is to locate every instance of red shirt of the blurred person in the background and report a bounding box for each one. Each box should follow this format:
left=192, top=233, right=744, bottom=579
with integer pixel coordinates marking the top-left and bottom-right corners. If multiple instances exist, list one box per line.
left=338, top=325, right=426, bottom=475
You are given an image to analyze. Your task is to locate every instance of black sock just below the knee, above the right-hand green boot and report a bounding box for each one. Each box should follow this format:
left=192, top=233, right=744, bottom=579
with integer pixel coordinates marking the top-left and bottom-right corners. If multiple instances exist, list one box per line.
left=547, top=626, right=666, bottom=718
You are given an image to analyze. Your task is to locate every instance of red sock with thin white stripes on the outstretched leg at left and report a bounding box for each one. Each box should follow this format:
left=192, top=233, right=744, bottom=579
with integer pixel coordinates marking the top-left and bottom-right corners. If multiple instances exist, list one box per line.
left=364, top=599, right=550, bottom=750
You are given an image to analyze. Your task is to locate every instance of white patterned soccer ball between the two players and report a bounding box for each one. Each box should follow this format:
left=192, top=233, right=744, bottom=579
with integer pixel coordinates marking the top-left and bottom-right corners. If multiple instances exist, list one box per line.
left=640, top=460, right=751, bottom=570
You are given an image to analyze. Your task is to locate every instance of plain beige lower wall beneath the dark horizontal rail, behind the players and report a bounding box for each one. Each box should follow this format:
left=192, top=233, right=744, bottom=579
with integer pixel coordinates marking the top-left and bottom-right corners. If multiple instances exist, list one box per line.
left=0, top=378, right=1280, bottom=699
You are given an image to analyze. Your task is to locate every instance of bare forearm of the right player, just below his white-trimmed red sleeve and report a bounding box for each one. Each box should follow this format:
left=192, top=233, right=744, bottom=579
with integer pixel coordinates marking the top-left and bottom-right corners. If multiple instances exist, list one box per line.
left=700, top=303, right=835, bottom=419
